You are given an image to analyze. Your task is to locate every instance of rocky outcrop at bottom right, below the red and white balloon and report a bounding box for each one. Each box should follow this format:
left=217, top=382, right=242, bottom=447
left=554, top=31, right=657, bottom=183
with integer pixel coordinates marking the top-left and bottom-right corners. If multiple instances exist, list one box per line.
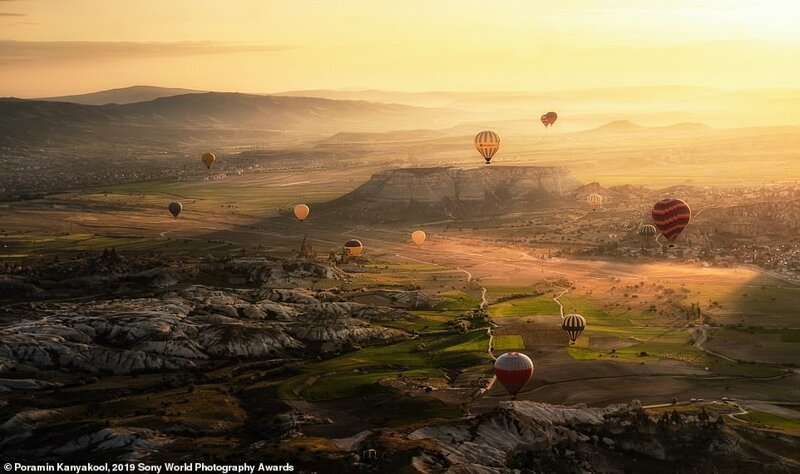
left=408, top=401, right=788, bottom=473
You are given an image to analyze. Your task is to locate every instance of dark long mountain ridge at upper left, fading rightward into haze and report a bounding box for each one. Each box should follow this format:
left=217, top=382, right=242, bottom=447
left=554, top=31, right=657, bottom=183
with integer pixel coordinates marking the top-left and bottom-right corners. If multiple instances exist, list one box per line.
left=0, top=91, right=461, bottom=146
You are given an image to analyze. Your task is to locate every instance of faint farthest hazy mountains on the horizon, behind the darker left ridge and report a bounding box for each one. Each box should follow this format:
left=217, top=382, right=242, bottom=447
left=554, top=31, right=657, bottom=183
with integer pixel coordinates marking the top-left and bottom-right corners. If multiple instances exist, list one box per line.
left=20, top=85, right=800, bottom=132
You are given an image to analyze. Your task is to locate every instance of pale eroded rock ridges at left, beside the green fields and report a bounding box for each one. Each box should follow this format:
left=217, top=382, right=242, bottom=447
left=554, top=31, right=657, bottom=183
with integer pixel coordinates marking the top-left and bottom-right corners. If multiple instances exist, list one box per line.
left=0, top=286, right=409, bottom=378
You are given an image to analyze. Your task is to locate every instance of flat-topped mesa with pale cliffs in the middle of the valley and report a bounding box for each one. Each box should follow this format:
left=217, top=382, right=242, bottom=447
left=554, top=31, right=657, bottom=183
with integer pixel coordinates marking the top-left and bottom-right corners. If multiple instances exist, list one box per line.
left=324, top=165, right=581, bottom=221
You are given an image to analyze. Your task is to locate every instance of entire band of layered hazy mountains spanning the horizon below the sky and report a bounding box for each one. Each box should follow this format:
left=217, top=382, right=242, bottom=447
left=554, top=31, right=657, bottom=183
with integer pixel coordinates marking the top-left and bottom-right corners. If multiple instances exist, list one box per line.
left=7, top=85, right=800, bottom=149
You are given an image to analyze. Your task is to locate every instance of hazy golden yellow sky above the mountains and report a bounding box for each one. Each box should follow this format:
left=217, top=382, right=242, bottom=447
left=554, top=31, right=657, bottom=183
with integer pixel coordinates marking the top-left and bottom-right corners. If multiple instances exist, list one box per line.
left=0, top=0, right=800, bottom=97
